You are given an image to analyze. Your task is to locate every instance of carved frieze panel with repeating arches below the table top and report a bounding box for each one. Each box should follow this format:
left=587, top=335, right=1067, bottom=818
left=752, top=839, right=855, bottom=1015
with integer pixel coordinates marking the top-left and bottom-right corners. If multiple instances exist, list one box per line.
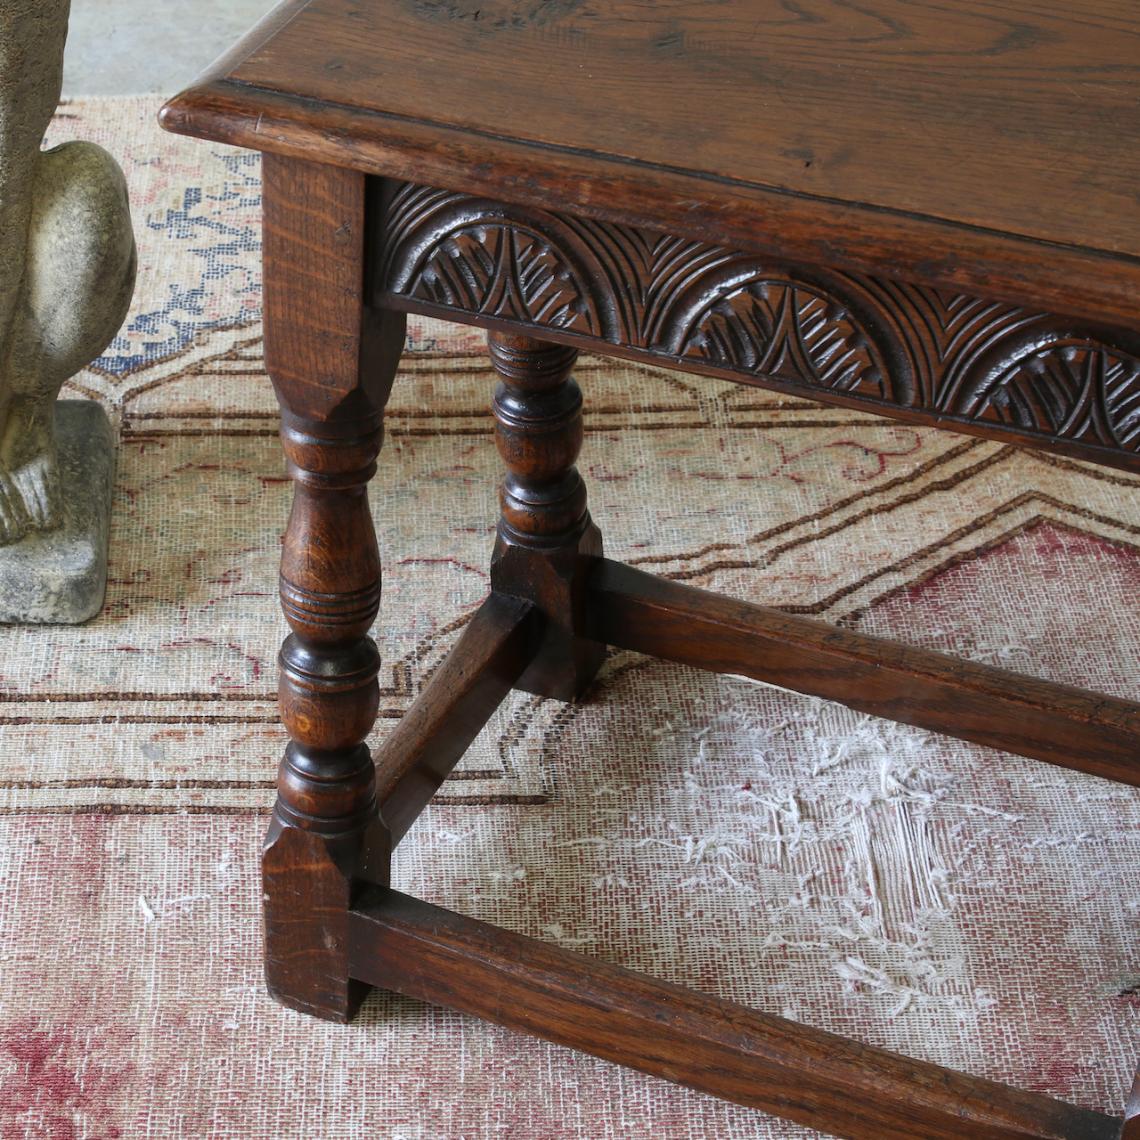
left=373, top=182, right=1140, bottom=466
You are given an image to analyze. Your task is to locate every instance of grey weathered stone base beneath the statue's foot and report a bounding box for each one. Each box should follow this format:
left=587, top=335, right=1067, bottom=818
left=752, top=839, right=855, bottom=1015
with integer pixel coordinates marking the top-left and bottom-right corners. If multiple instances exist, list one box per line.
left=0, top=400, right=115, bottom=625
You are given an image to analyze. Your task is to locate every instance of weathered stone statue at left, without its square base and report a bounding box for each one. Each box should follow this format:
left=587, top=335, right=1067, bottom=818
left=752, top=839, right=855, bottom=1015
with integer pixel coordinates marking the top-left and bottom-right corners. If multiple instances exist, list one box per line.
left=0, top=0, right=136, bottom=620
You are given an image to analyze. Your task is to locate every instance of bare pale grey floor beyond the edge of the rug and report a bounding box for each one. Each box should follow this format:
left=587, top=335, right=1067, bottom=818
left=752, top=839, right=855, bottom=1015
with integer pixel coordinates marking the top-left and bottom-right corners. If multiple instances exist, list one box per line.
left=64, top=0, right=275, bottom=95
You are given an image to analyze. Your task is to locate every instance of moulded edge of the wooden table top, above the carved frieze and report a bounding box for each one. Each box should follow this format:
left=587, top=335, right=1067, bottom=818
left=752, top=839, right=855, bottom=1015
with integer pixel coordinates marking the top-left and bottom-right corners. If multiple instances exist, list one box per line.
left=160, top=76, right=1140, bottom=327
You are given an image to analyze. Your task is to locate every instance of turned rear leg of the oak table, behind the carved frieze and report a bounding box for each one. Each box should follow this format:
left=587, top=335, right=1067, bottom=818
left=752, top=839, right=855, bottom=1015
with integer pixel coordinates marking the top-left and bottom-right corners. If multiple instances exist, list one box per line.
left=488, top=333, right=605, bottom=700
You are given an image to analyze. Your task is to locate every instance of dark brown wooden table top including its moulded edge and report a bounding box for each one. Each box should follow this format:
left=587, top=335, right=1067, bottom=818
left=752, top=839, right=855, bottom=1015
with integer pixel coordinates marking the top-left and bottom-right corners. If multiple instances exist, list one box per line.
left=164, top=0, right=1140, bottom=326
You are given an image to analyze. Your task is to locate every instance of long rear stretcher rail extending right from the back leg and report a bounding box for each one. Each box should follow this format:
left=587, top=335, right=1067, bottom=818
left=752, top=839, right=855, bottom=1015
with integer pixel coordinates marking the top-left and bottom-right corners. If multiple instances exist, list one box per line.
left=586, top=560, right=1140, bottom=784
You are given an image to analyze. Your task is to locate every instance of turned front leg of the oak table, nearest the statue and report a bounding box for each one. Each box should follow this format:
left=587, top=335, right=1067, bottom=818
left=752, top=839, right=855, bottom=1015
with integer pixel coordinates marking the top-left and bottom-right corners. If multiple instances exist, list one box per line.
left=262, top=155, right=404, bottom=1020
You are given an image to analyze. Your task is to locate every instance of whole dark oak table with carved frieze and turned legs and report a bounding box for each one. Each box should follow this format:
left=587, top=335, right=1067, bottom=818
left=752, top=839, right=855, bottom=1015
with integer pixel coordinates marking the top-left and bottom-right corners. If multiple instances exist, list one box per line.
left=162, top=0, right=1140, bottom=1140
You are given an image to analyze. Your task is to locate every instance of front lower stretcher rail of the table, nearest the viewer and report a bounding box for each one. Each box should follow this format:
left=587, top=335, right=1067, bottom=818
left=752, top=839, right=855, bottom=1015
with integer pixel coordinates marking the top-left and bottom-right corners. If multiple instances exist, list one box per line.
left=349, top=889, right=1121, bottom=1140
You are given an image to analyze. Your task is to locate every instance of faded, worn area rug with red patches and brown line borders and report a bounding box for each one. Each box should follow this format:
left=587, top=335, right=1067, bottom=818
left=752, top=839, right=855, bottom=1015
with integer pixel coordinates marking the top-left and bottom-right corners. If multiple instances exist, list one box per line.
left=0, top=99, right=1140, bottom=1140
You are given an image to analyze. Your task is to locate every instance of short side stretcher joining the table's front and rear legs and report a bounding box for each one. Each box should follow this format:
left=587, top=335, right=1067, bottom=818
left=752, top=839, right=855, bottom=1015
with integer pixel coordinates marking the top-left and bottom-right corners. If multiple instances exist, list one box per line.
left=375, top=594, right=538, bottom=847
